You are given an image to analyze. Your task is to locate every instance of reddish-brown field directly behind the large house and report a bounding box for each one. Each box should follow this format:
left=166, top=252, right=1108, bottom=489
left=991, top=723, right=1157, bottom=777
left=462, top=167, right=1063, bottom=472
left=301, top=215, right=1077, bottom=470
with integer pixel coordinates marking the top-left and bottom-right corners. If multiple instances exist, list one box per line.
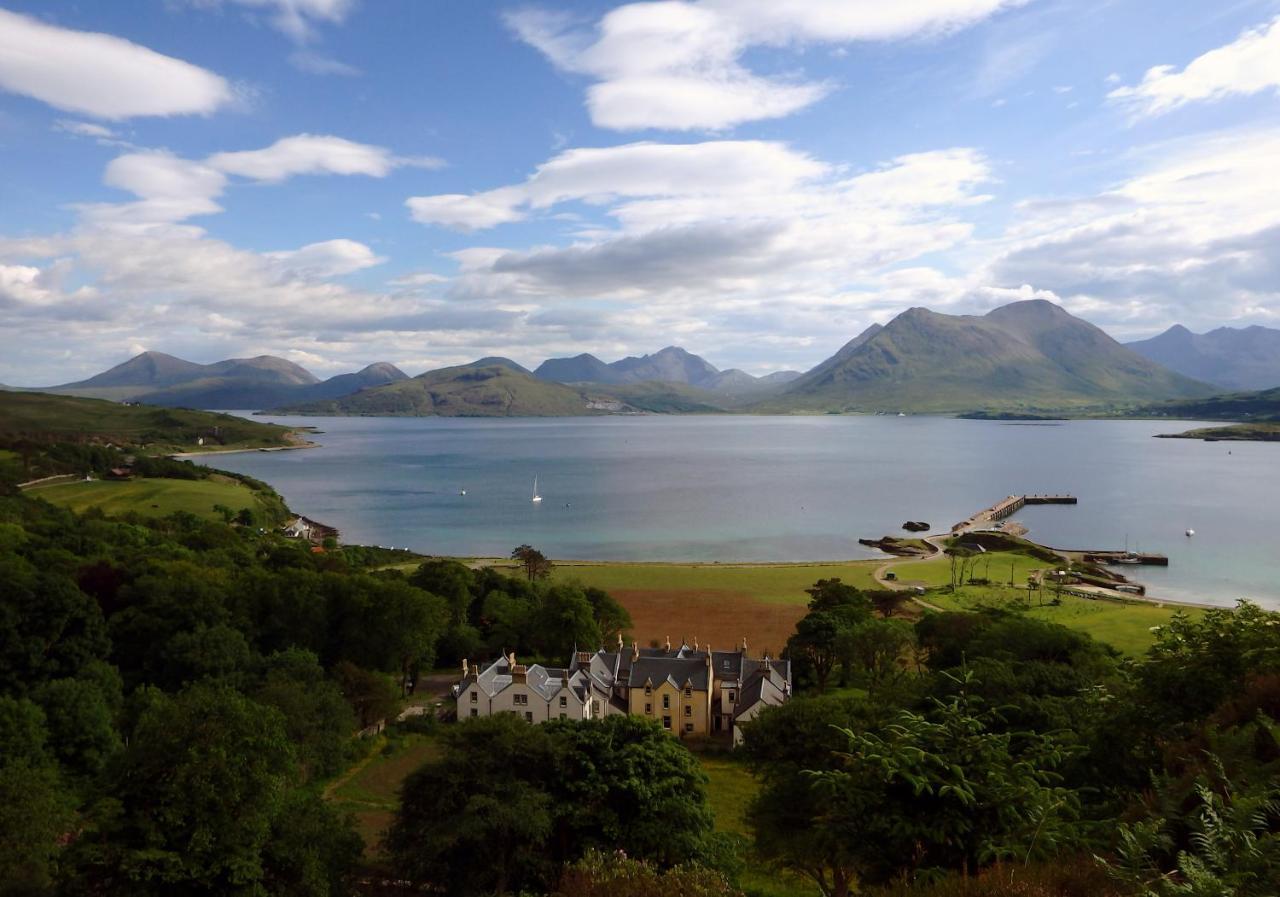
left=612, top=589, right=808, bottom=655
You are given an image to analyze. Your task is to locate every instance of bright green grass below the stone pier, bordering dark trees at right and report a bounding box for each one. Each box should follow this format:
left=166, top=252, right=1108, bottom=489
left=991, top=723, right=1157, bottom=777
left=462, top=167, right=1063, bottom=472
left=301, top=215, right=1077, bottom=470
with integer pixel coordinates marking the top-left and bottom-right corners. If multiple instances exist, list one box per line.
left=924, top=580, right=1203, bottom=655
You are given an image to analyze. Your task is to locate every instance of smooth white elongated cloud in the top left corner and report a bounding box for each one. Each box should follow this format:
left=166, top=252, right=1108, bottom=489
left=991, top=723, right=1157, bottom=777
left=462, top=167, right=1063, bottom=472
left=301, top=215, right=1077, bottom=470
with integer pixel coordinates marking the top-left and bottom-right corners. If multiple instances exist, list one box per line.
left=0, top=9, right=233, bottom=120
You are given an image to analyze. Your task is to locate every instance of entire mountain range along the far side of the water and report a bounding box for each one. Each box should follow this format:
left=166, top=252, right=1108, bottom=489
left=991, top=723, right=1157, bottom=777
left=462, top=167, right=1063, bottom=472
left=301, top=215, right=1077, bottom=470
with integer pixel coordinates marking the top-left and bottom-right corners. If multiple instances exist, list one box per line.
left=20, top=299, right=1259, bottom=416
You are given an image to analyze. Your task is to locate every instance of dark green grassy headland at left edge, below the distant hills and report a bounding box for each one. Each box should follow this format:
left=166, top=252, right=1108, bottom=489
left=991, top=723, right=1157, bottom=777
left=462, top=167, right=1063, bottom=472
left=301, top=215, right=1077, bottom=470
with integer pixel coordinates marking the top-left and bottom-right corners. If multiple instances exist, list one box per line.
left=0, top=392, right=289, bottom=452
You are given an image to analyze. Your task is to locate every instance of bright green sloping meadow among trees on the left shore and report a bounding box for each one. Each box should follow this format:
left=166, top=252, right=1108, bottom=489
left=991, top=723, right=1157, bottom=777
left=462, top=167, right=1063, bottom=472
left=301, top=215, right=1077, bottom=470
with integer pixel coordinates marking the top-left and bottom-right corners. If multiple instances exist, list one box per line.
left=26, top=475, right=273, bottom=520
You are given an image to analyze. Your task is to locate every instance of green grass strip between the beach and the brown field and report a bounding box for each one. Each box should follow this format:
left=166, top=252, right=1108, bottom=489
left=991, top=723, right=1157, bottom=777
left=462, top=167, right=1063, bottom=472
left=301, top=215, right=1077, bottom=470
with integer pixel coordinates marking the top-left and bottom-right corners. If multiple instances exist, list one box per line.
left=552, top=560, right=879, bottom=605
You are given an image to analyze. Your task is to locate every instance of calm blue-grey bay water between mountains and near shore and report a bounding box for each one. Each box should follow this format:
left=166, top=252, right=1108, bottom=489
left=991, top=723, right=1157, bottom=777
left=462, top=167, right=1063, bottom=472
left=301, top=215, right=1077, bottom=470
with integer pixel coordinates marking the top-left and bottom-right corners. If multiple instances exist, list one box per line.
left=202, top=416, right=1280, bottom=607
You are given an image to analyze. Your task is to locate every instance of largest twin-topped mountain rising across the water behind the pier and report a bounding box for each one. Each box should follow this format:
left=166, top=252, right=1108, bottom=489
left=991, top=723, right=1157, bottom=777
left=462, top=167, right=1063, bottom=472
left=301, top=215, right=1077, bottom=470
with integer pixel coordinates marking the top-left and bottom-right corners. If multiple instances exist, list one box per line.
left=754, top=301, right=1212, bottom=412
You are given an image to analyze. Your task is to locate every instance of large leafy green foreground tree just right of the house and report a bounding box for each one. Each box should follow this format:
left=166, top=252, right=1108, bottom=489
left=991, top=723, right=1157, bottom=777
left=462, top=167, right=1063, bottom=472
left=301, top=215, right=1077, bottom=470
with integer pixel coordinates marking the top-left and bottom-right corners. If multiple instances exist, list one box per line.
left=800, top=680, right=1079, bottom=897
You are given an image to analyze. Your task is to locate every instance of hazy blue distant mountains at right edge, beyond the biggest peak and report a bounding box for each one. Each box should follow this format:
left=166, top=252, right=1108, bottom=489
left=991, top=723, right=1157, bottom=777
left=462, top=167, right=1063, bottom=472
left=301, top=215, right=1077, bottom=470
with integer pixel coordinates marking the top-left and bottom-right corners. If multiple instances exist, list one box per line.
left=1126, top=324, right=1280, bottom=392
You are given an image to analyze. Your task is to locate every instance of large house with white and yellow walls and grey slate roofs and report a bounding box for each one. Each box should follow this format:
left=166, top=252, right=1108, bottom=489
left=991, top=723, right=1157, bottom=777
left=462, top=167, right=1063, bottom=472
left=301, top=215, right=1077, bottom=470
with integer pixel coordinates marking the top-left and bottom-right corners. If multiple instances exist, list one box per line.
left=454, top=639, right=791, bottom=743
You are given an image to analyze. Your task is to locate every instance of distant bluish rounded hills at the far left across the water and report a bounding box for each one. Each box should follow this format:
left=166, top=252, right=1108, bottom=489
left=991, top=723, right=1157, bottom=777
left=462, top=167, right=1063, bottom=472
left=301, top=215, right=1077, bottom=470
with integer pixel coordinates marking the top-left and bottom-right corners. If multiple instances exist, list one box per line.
left=35, top=352, right=407, bottom=408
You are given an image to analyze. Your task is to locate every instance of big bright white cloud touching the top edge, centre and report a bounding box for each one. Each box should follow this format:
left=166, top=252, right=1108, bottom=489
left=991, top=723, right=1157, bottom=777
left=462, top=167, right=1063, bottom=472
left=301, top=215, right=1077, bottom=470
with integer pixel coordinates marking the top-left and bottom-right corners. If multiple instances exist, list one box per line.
left=507, top=0, right=1025, bottom=131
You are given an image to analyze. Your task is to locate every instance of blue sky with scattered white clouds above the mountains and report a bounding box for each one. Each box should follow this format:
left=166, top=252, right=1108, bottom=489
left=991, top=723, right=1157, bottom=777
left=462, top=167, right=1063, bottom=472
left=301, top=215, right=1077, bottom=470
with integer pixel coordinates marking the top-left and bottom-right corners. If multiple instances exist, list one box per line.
left=0, top=0, right=1280, bottom=385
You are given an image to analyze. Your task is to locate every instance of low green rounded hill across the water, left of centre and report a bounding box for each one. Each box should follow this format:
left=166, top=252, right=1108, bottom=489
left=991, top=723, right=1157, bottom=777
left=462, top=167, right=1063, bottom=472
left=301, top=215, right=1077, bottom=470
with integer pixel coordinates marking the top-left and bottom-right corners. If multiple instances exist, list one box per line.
left=272, top=362, right=601, bottom=417
